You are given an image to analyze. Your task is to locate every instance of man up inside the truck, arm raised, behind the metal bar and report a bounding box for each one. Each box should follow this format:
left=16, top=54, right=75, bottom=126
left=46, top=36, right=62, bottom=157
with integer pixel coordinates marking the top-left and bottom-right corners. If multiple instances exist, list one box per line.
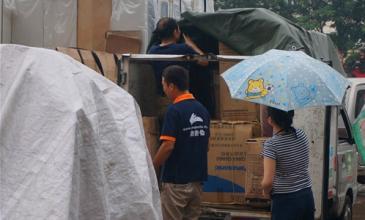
left=148, top=17, right=208, bottom=96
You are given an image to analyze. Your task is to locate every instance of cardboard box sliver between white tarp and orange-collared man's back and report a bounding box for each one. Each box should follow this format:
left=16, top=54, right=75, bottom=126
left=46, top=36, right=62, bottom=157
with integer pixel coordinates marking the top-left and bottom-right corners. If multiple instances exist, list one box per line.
left=142, top=117, right=160, bottom=158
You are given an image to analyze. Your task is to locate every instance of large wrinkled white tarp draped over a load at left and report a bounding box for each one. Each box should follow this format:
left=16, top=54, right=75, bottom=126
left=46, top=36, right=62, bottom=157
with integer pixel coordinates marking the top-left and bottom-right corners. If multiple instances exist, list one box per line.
left=0, top=45, right=162, bottom=220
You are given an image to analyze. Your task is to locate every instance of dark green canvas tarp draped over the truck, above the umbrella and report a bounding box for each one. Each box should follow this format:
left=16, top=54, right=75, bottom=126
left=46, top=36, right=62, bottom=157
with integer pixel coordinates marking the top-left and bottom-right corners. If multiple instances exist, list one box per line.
left=181, top=8, right=345, bottom=75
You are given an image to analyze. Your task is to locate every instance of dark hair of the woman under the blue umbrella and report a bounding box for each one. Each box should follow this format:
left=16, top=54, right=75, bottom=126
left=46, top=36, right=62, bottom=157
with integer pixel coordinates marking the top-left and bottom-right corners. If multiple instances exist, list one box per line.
left=267, top=107, right=295, bottom=133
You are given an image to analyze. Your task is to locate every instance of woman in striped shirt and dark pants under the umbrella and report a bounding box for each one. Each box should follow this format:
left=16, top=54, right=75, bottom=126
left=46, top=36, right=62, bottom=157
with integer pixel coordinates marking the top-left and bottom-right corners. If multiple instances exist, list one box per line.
left=261, top=107, right=315, bottom=220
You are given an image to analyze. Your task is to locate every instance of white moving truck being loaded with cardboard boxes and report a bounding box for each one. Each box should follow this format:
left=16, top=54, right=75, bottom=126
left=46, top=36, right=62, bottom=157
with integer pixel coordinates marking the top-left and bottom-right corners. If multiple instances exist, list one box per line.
left=118, top=54, right=358, bottom=219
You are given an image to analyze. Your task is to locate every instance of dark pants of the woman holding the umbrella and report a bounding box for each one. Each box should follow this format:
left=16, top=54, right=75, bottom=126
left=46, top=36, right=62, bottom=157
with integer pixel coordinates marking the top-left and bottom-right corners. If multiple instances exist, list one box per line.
left=271, top=188, right=315, bottom=220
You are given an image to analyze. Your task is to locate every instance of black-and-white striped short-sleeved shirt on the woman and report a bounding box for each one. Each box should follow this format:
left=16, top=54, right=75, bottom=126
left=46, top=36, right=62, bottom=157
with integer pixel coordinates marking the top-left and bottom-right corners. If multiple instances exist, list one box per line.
left=262, top=129, right=312, bottom=194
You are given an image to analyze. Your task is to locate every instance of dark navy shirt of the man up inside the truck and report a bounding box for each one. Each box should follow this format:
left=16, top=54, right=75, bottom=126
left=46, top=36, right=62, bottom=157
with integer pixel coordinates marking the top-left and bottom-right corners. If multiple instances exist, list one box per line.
left=148, top=43, right=197, bottom=95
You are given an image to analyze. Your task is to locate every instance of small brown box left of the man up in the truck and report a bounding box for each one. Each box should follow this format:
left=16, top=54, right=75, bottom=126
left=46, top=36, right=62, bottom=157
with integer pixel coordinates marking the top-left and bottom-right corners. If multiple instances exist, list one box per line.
left=105, top=31, right=143, bottom=54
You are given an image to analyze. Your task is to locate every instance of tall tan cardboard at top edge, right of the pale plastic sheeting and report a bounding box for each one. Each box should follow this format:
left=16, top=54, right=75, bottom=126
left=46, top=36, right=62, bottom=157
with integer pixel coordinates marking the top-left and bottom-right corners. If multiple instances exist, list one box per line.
left=77, top=0, right=112, bottom=51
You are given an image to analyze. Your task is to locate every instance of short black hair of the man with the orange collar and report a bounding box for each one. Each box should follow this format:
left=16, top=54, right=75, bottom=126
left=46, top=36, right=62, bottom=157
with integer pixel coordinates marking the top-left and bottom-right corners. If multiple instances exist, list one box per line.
left=162, top=65, right=189, bottom=91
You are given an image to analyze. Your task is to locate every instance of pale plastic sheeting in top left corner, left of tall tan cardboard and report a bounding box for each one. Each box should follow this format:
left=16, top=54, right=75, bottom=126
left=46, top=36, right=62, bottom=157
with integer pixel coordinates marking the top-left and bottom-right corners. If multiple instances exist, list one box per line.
left=3, top=0, right=77, bottom=48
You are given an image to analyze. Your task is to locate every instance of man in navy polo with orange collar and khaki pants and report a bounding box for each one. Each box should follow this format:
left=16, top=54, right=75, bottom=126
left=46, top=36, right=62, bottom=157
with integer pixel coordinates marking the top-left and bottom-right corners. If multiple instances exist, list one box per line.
left=153, top=65, right=210, bottom=220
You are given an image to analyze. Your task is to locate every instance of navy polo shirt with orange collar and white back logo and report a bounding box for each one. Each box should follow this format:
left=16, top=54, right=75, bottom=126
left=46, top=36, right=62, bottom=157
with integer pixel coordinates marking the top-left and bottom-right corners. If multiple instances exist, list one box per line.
left=160, top=93, right=210, bottom=184
